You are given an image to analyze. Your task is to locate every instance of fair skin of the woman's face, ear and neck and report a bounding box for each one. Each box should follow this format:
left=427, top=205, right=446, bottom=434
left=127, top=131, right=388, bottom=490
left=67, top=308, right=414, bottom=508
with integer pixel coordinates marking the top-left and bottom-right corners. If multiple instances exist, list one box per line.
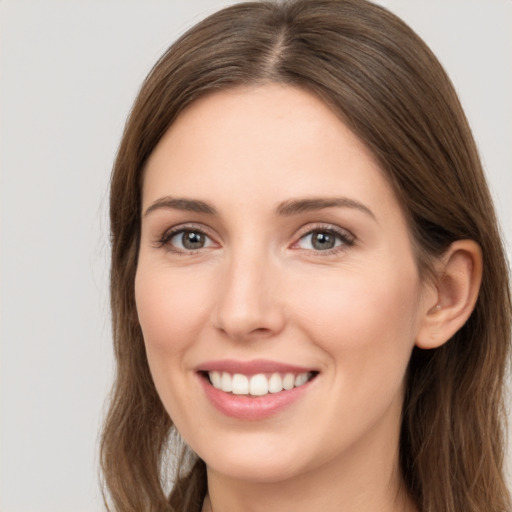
left=135, top=85, right=480, bottom=512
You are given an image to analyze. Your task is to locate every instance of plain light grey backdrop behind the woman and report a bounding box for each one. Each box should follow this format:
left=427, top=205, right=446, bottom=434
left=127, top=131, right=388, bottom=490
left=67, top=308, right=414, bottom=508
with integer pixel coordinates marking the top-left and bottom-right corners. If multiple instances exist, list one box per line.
left=0, top=0, right=512, bottom=512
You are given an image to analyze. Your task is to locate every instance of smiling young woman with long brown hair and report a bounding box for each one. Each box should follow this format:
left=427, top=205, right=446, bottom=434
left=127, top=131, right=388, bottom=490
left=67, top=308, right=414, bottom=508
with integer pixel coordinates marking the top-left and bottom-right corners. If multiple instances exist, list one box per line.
left=102, top=0, right=511, bottom=512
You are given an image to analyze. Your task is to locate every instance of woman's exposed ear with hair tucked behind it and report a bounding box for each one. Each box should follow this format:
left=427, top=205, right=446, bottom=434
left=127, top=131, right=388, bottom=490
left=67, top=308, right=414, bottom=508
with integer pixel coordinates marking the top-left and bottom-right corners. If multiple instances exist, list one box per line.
left=416, top=240, right=482, bottom=349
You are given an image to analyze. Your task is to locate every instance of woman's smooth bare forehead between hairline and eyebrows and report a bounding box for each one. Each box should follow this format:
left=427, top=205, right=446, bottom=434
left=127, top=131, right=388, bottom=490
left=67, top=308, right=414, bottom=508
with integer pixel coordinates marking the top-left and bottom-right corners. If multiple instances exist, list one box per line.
left=143, top=84, right=396, bottom=218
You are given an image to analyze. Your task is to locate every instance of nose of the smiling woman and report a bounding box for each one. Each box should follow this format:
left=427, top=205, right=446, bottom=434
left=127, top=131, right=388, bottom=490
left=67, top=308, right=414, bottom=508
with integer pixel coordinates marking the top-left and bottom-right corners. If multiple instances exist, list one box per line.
left=214, top=248, right=285, bottom=341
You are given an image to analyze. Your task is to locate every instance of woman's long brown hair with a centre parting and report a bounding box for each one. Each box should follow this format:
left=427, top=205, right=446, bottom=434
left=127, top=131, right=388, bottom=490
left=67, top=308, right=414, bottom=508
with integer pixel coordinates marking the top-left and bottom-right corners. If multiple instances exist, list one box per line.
left=101, top=0, right=511, bottom=512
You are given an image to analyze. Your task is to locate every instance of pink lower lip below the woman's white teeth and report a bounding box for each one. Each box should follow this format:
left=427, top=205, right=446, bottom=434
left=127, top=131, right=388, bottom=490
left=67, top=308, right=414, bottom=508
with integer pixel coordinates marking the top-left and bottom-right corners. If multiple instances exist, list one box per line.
left=199, top=375, right=312, bottom=421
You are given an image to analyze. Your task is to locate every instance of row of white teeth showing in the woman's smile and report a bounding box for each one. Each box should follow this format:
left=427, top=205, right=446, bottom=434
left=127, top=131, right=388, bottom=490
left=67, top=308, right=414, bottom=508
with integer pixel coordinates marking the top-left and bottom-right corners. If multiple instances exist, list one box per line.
left=208, top=371, right=312, bottom=396
